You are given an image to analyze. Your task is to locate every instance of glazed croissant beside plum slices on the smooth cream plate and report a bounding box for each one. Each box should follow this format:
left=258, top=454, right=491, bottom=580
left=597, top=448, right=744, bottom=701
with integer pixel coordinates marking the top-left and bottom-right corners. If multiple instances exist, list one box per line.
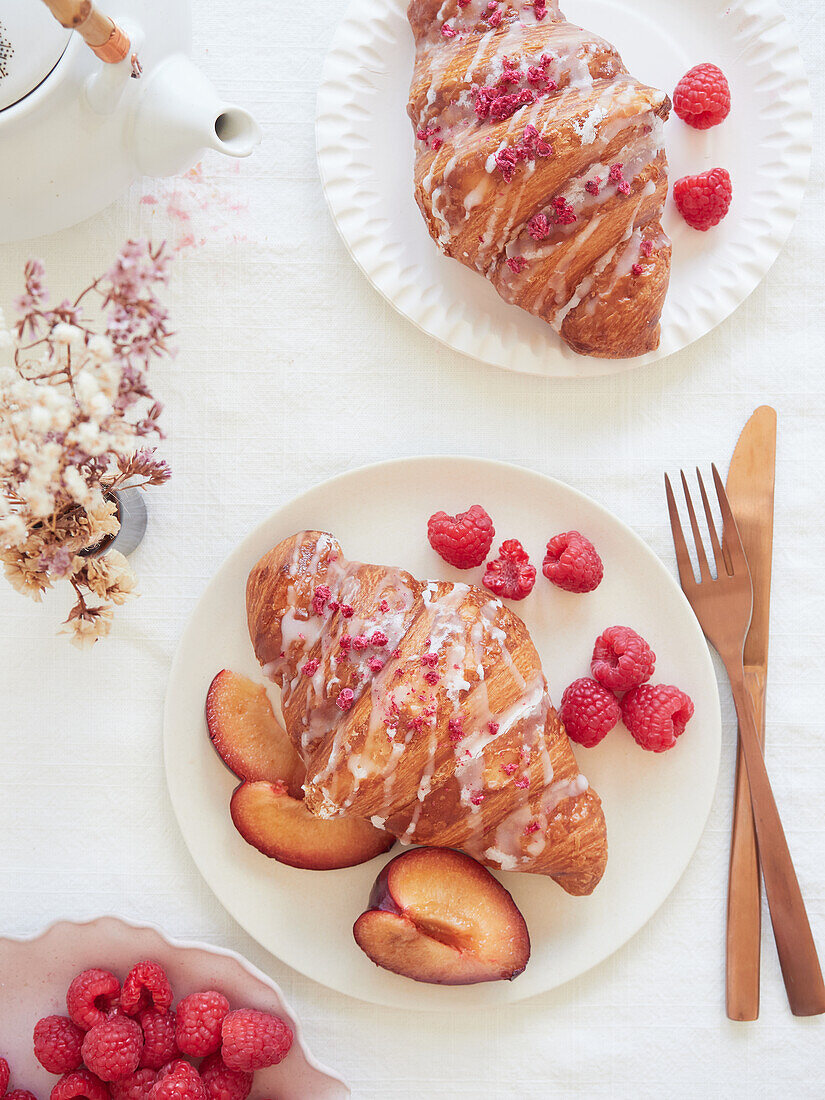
left=246, top=531, right=607, bottom=894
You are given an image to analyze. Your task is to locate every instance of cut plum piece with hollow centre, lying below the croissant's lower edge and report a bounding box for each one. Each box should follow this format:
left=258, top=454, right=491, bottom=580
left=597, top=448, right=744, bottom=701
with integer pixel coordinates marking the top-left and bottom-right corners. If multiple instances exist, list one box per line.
left=353, top=848, right=530, bottom=986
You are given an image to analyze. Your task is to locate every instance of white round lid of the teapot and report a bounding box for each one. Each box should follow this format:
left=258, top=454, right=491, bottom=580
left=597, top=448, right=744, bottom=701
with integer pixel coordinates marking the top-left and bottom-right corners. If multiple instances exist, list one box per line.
left=0, top=0, right=72, bottom=111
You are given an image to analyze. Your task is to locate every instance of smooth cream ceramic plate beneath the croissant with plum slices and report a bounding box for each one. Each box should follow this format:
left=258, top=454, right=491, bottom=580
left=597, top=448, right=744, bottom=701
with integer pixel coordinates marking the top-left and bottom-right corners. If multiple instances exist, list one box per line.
left=164, top=458, right=721, bottom=1010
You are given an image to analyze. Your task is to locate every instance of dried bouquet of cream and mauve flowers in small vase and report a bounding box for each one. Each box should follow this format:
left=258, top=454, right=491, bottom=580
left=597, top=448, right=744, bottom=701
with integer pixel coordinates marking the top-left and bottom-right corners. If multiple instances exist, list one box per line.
left=0, top=241, right=174, bottom=648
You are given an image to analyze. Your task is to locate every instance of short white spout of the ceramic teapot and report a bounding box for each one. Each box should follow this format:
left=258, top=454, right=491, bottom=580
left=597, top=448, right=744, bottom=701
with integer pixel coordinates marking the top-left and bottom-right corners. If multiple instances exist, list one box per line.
left=134, top=54, right=261, bottom=176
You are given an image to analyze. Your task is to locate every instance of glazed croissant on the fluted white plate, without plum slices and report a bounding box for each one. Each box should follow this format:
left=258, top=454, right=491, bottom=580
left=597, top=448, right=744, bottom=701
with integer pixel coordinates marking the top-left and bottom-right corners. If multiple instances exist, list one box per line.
left=407, top=0, right=671, bottom=359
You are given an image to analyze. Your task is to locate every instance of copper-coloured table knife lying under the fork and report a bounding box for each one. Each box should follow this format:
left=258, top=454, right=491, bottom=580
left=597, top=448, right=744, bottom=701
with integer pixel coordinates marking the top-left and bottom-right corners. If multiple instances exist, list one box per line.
left=726, top=405, right=777, bottom=1020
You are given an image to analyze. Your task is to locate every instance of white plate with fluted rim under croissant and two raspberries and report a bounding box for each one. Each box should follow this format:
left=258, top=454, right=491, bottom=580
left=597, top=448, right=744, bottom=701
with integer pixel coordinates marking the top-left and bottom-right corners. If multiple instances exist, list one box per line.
left=316, top=0, right=811, bottom=376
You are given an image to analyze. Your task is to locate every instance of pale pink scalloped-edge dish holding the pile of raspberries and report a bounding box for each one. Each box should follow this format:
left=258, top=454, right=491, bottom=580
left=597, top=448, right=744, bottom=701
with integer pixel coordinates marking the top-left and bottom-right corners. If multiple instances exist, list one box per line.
left=0, top=916, right=350, bottom=1100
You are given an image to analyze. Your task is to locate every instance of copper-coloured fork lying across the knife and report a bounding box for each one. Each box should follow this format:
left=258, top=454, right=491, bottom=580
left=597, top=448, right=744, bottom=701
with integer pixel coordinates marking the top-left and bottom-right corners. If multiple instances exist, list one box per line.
left=664, top=465, right=825, bottom=1016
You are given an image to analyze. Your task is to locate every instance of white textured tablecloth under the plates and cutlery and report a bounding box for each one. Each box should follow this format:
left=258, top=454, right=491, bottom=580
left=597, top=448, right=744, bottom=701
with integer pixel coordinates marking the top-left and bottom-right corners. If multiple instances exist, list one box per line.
left=0, top=0, right=825, bottom=1100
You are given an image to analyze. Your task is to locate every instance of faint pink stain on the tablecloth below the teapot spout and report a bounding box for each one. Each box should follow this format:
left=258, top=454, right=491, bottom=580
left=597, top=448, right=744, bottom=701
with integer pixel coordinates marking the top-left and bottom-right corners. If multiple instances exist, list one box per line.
left=140, top=163, right=249, bottom=252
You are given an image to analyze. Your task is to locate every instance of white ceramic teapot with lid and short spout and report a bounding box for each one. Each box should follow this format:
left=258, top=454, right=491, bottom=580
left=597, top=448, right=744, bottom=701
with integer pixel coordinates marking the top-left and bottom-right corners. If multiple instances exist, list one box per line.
left=0, top=0, right=261, bottom=242
